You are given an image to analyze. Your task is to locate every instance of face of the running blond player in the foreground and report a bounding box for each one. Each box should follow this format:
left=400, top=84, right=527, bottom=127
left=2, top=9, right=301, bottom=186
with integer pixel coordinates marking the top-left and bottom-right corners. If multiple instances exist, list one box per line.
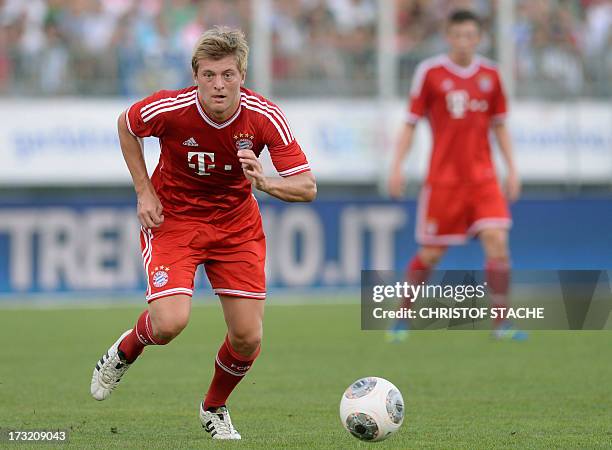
left=193, top=55, right=244, bottom=122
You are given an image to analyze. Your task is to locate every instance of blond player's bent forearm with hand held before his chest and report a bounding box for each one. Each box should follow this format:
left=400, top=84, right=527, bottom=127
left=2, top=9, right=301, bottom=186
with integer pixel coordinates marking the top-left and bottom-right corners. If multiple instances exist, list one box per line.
left=238, top=150, right=317, bottom=202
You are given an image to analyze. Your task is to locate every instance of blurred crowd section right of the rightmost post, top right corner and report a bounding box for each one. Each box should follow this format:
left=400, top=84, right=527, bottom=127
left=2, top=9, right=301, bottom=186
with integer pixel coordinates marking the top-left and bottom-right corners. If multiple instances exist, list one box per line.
left=514, top=0, right=612, bottom=97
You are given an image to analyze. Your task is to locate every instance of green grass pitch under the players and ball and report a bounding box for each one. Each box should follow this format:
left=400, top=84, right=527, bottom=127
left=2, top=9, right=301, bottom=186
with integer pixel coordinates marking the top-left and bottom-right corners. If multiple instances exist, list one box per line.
left=0, top=299, right=612, bottom=449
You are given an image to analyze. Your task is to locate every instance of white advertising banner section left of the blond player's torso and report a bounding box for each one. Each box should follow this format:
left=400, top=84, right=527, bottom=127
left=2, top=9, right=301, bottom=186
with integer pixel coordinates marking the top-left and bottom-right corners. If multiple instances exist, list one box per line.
left=0, top=99, right=159, bottom=186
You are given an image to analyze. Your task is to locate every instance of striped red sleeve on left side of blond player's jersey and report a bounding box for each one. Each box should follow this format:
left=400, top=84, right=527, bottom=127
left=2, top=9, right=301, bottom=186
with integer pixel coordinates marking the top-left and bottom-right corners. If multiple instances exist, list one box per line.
left=125, top=88, right=196, bottom=138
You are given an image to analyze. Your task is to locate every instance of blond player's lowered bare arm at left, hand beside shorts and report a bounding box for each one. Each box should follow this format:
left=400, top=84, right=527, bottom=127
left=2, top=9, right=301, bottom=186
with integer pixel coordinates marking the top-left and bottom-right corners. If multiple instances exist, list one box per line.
left=117, top=112, right=164, bottom=228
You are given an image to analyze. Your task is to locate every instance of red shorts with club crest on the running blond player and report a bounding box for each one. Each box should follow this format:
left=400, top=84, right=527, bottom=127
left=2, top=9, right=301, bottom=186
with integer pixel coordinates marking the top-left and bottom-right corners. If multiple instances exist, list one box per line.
left=140, top=209, right=266, bottom=302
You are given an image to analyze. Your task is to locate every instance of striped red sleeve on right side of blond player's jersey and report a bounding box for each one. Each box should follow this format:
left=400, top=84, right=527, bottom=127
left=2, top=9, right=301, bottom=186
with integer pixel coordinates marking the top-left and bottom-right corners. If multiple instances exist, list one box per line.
left=241, top=92, right=310, bottom=177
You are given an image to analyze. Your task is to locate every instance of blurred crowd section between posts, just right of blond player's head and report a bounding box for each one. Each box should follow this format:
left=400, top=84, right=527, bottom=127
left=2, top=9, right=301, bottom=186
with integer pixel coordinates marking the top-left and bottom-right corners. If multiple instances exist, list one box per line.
left=271, top=0, right=378, bottom=95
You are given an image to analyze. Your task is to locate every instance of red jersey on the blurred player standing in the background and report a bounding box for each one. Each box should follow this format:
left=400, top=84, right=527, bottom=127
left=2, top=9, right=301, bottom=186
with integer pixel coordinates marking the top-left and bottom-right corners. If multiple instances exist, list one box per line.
left=406, top=55, right=507, bottom=185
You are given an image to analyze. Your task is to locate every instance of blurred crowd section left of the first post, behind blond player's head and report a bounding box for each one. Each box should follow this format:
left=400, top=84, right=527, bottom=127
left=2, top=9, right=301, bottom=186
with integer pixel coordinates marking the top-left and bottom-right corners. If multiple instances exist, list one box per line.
left=0, top=0, right=251, bottom=95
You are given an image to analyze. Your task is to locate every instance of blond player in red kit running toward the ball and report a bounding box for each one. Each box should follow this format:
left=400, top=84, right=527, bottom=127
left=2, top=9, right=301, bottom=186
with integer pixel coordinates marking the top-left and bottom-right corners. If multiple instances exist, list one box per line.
left=91, top=27, right=316, bottom=439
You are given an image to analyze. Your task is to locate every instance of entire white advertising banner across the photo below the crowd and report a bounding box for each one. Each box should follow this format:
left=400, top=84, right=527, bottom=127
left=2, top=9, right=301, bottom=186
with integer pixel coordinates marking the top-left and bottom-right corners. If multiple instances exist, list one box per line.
left=0, top=99, right=612, bottom=186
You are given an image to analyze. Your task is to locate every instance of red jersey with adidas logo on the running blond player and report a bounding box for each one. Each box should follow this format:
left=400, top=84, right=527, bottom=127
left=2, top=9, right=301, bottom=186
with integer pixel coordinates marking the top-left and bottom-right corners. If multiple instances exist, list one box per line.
left=126, top=86, right=310, bottom=222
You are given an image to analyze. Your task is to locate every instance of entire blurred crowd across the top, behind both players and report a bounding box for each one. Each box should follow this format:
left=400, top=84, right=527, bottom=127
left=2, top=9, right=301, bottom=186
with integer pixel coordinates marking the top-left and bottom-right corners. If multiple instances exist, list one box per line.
left=0, top=0, right=612, bottom=97
